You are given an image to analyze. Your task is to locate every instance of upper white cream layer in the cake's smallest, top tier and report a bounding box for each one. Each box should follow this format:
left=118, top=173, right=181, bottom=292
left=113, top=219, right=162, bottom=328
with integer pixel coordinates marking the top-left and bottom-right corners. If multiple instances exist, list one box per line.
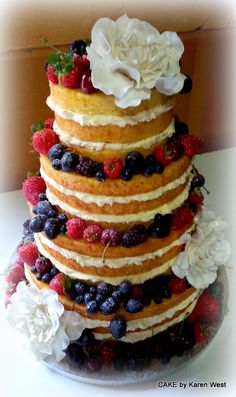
left=46, top=95, right=175, bottom=127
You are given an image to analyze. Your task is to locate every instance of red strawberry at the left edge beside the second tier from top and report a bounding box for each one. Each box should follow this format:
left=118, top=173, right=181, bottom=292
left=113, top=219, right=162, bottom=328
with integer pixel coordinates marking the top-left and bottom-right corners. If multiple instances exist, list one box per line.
left=22, top=176, right=46, bottom=205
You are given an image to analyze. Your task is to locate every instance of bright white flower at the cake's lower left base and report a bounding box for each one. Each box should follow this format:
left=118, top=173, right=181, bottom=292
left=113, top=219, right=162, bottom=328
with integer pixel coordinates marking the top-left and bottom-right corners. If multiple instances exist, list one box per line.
left=7, top=282, right=85, bottom=361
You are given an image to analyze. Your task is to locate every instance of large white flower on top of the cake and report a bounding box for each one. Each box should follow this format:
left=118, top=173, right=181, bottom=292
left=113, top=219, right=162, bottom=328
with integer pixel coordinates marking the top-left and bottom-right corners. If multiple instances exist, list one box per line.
left=87, top=15, right=185, bottom=108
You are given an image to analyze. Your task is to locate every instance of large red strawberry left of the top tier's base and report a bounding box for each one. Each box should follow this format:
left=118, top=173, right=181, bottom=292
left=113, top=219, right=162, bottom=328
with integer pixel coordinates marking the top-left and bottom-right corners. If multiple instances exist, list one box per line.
left=32, top=128, right=59, bottom=156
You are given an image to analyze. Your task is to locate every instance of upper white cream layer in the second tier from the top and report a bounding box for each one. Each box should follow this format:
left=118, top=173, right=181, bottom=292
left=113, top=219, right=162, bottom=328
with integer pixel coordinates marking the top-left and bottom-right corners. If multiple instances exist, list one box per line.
left=40, top=165, right=192, bottom=207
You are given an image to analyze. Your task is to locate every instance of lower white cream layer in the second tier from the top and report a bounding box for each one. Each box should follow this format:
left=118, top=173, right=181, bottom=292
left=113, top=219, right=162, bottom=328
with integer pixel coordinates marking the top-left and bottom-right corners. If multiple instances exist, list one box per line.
left=46, top=179, right=191, bottom=223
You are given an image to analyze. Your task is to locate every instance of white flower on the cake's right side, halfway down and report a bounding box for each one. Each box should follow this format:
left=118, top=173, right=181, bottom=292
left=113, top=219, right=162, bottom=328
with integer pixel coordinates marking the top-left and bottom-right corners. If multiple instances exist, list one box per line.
left=172, top=208, right=230, bottom=288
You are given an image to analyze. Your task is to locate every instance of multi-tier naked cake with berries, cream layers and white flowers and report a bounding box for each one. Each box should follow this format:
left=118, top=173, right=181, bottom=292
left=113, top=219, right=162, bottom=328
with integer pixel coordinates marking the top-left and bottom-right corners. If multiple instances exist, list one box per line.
left=7, top=16, right=229, bottom=370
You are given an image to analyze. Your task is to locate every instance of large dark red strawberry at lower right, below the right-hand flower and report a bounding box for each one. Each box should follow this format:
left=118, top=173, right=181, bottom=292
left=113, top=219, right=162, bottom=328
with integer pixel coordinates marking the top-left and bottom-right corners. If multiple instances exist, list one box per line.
left=188, top=292, right=221, bottom=324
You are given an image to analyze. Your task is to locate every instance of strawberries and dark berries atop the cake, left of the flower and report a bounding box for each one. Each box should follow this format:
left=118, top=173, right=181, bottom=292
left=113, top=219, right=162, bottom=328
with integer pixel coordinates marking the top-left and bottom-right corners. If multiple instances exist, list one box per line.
left=45, top=40, right=96, bottom=94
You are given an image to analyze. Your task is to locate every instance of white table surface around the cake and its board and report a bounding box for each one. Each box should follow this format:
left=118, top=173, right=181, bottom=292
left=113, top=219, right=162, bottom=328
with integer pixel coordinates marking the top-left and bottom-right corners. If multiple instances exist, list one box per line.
left=0, top=148, right=236, bottom=397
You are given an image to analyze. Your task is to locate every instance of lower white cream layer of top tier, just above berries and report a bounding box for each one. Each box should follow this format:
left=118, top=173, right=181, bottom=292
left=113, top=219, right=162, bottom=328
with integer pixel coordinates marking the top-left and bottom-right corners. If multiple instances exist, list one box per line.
left=53, top=119, right=175, bottom=152
